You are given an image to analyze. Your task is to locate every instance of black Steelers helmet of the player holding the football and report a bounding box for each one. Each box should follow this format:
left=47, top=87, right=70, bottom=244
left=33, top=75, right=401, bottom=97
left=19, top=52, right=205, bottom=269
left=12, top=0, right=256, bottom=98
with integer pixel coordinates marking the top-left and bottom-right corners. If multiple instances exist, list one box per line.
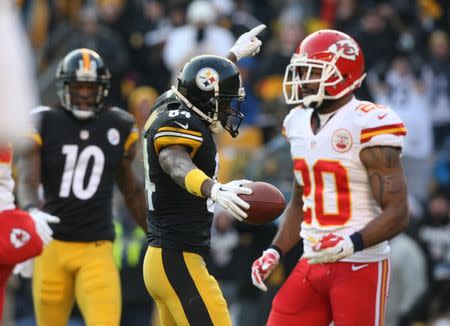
left=172, top=55, right=245, bottom=137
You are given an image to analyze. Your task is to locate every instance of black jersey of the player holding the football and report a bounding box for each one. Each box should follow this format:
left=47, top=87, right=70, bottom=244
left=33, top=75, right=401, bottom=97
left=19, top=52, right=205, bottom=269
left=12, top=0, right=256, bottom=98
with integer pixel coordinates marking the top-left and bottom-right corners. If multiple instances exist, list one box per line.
left=143, top=93, right=218, bottom=255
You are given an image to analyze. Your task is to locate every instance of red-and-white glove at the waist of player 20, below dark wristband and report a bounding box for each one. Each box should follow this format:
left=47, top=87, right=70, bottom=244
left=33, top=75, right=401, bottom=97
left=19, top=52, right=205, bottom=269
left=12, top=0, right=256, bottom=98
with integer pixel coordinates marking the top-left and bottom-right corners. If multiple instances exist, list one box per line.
left=303, top=233, right=355, bottom=264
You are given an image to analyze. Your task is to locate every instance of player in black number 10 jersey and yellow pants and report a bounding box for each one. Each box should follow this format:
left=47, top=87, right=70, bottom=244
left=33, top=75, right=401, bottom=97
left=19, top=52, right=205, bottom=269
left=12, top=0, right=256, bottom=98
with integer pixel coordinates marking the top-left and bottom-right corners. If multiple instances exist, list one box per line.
left=14, top=49, right=146, bottom=326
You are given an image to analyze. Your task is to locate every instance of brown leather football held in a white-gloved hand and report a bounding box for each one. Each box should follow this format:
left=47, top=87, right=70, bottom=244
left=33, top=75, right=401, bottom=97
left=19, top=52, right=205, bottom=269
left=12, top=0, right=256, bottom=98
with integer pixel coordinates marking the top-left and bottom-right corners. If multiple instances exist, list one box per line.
left=239, top=181, right=286, bottom=225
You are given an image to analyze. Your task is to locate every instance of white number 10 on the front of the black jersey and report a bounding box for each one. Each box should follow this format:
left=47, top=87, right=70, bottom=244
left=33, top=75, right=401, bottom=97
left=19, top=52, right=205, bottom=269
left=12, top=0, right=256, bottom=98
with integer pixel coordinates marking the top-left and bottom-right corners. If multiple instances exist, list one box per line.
left=59, top=145, right=105, bottom=200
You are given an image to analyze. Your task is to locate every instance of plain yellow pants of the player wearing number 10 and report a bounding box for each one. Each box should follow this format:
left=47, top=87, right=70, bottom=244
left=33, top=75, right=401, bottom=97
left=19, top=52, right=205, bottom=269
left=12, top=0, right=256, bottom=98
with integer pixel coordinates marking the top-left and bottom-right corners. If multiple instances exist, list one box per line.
left=33, top=240, right=122, bottom=326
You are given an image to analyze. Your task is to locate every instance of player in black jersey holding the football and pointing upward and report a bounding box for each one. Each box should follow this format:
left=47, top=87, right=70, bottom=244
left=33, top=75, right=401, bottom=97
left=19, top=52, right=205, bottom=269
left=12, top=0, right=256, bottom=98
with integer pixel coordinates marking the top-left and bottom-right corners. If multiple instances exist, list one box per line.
left=143, top=25, right=264, bottom=326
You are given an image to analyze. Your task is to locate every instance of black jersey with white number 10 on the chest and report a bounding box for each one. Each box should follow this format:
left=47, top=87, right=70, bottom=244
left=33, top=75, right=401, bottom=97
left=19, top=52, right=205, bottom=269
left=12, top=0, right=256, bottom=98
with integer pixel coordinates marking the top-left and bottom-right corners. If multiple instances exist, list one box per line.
left=33, top=107, right=139, bottom=241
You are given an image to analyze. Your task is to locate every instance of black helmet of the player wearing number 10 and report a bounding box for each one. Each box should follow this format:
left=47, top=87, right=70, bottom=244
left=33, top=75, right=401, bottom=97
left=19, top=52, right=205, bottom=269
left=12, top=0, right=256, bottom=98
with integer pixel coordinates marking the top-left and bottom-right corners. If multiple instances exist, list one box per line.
left=56, top=49, right=111, bottom=119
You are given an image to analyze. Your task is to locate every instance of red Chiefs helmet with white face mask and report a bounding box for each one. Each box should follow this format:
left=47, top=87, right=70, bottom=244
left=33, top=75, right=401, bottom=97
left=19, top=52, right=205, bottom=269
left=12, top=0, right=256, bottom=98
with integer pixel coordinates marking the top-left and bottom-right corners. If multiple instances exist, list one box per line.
left=283, top=29, right=366, bottom=107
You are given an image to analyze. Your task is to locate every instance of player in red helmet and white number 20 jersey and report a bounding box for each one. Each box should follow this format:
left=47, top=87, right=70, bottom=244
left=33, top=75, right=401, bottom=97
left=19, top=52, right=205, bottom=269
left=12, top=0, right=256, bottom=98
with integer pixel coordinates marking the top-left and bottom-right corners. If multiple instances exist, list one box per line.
left=252, top=30, right=408, bottom=326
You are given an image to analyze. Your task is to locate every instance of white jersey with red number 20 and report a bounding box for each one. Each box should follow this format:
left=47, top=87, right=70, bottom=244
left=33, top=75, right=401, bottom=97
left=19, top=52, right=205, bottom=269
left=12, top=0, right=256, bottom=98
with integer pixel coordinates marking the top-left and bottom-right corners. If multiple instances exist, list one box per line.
left=283, top=98, right=406, bottom=262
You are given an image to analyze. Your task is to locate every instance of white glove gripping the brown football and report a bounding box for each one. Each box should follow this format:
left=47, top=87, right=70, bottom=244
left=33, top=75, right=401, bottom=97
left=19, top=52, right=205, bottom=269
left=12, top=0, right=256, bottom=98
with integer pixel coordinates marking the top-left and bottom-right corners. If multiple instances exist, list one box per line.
left=211, top=180, right=253, bottom=221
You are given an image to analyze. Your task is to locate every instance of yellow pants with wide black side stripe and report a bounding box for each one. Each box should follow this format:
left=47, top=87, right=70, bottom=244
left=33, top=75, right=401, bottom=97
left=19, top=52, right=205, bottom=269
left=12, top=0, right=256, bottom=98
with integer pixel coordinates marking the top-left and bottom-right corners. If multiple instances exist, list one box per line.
left=143, top=247, right=231, bottom=326
